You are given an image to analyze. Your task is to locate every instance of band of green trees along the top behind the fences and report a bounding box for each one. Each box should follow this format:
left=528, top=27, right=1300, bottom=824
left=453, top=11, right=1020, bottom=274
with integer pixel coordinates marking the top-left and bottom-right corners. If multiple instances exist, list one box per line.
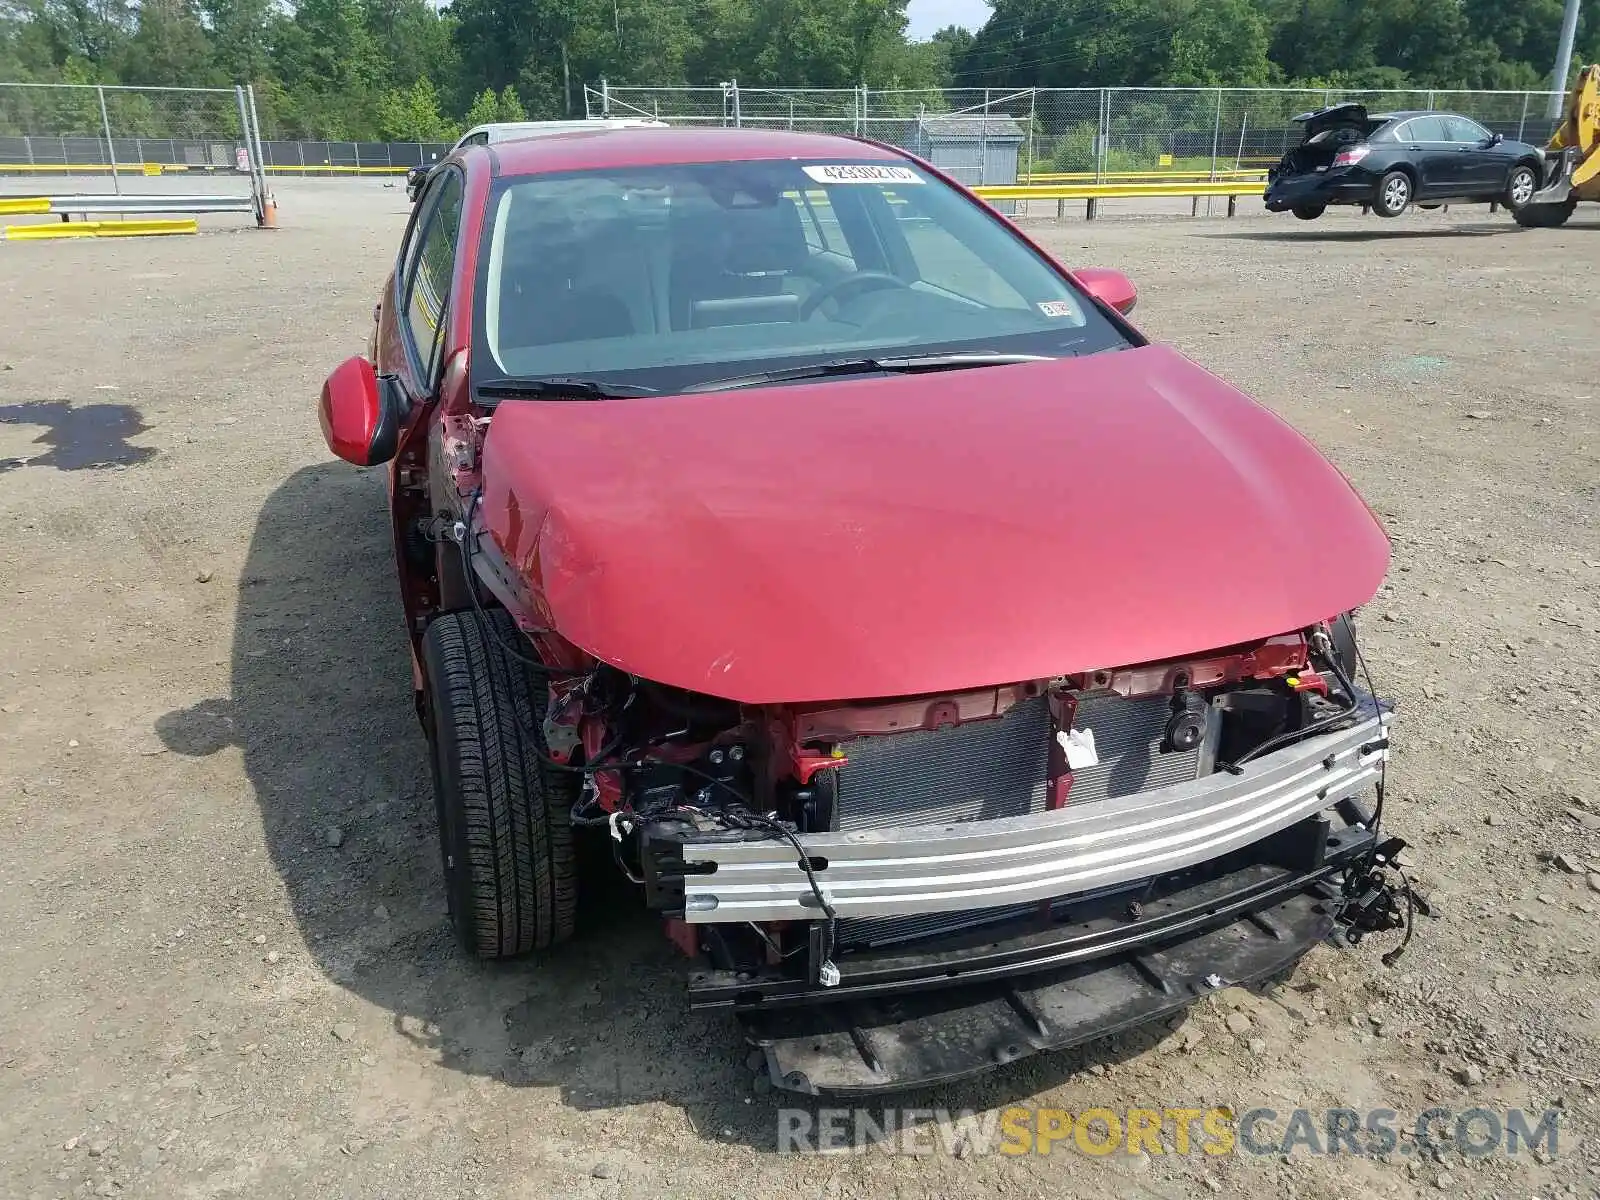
left=0, top=0, right=1600, bottom=143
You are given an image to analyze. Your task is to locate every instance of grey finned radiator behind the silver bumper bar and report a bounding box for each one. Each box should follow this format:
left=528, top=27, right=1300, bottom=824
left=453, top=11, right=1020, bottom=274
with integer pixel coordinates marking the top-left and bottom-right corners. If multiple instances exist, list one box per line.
left=837, top=691, right=1206, bottom=946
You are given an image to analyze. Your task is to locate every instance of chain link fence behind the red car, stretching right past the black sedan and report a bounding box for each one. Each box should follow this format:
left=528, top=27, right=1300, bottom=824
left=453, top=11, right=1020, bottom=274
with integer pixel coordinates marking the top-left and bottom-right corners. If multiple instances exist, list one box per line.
left=584, top=82, right=1557, bottom=184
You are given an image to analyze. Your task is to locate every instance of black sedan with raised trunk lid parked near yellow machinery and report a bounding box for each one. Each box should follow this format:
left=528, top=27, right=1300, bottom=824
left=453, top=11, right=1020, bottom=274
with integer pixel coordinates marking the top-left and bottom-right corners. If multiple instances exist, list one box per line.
left=1266, top=104, right=1544, bottom=221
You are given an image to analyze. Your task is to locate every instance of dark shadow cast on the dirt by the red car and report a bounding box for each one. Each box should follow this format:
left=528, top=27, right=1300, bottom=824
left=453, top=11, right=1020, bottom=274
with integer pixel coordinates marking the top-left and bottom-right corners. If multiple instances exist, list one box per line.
left=157, top=464, right=1184, bottom=1149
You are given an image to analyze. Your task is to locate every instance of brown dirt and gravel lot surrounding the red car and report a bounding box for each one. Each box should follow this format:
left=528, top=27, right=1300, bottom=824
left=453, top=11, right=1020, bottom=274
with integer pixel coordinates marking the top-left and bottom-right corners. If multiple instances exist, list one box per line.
left=0, top=181, right=1600, bottom=1200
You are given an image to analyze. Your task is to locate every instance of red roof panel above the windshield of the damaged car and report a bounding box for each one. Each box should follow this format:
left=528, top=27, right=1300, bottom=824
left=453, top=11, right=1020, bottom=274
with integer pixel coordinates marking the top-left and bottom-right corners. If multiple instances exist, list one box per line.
left=490, top=128, right=907, bottom=176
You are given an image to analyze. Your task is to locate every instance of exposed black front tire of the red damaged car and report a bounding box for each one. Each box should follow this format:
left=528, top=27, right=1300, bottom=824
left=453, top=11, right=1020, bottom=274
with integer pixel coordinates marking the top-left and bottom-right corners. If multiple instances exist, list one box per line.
left=422, top=610, right=579, bottom=958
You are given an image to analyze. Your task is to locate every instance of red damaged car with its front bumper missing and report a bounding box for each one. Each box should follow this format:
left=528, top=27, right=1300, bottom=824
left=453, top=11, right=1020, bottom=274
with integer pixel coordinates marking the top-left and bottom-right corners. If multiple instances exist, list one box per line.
left=322, top=130, right=1406, bottom=1093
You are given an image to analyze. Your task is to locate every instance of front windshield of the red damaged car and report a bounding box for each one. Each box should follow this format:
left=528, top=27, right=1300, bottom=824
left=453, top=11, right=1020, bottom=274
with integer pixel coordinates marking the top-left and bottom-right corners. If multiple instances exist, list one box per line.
left=474, top=160, right=1128, bottom=392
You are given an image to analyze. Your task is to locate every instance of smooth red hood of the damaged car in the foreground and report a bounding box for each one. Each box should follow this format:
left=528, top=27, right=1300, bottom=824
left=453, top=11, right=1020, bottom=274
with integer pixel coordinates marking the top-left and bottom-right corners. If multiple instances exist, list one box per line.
left=483, top=346, right=1389, bottom=704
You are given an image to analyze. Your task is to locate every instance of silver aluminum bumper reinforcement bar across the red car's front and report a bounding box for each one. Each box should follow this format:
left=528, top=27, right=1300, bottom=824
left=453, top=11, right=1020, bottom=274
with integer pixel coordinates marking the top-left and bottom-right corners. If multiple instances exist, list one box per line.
left=683, top=698, right=1389, bottom=923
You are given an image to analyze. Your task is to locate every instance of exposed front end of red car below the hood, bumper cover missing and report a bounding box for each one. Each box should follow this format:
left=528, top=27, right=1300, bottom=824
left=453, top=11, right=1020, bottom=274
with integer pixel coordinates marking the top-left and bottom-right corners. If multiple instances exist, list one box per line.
left=585, top=618, right=1410, bottom=1094
